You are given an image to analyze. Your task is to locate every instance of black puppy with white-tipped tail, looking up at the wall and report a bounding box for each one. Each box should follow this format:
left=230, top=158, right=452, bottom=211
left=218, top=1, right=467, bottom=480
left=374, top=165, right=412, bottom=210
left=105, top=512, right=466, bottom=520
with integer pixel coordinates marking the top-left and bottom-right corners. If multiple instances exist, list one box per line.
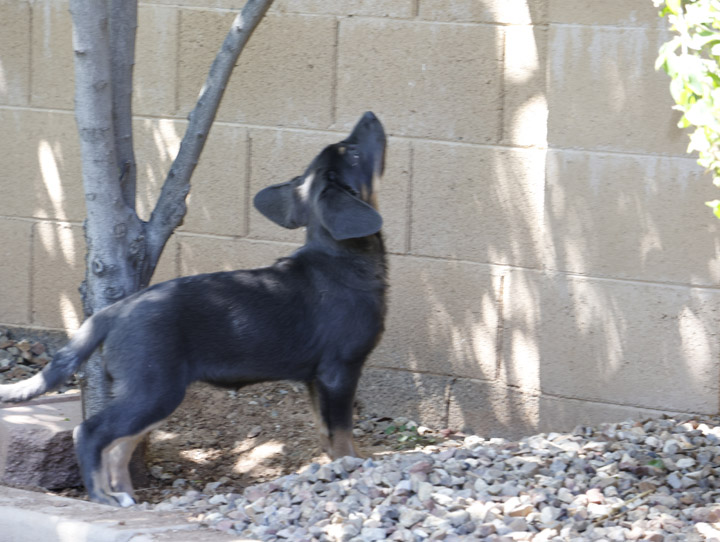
left=0, top=112, right=386, bottom=506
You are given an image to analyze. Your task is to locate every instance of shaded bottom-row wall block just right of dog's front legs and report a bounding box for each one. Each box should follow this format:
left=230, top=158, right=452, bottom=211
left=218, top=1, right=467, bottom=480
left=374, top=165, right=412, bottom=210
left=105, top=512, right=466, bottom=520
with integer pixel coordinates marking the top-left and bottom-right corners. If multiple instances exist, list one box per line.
left=357, top=367, right=452, bottom=429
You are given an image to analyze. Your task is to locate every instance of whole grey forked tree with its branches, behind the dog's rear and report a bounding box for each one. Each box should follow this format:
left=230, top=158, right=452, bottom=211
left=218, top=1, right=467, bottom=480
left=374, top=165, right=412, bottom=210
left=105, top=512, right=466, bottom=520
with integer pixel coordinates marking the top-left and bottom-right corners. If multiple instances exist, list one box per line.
left=70, top=0, right=272, bottom=484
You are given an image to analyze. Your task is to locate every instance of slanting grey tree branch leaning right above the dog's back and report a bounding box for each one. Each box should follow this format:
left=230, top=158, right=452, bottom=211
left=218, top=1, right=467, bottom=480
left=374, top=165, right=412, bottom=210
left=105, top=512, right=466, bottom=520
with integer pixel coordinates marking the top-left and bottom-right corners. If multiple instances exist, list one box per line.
left=144, top=0, right=273, bottom=284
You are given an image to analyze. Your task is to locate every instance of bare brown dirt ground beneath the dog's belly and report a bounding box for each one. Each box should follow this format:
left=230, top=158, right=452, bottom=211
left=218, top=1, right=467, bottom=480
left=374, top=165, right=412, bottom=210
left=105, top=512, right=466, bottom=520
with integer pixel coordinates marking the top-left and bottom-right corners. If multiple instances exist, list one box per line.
left=54, top=382, right=448, bottom=503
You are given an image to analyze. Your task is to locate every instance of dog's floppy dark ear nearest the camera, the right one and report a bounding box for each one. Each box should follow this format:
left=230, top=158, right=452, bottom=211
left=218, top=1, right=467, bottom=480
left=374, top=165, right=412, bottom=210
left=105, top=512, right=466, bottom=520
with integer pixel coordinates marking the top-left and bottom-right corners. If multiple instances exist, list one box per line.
left=318, top=186, right=382, bottom=241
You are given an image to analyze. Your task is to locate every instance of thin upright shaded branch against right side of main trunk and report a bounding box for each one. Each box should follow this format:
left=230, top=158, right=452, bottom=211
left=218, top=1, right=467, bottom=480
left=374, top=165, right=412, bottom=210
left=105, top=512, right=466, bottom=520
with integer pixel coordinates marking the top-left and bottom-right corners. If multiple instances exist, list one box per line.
left=110, top=0, right=137, bottom=210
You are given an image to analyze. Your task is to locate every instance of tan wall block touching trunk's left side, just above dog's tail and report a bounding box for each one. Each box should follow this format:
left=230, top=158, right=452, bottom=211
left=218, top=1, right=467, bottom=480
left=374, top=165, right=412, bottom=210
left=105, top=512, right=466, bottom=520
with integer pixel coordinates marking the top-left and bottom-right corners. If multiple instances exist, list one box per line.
left=32, top=222, right=85, bottom=330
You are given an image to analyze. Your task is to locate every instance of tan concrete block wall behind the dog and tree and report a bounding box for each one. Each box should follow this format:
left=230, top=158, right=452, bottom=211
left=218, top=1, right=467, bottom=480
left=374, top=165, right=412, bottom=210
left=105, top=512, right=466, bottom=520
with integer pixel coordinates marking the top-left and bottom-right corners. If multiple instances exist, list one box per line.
left=0, top=0, right=720, bottom=442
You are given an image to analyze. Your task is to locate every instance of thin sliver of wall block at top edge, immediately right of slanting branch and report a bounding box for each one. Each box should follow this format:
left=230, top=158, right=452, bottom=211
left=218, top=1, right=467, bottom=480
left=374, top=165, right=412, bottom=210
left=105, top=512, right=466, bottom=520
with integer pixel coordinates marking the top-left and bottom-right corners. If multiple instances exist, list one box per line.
left=271, top=0, right=414, bottom=19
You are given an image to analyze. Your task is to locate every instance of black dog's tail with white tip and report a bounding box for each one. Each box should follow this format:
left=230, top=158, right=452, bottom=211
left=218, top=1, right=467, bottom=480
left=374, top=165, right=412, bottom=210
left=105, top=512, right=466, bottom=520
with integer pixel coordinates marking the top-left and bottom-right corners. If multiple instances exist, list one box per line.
left=0, top=312, right=110, bottom=403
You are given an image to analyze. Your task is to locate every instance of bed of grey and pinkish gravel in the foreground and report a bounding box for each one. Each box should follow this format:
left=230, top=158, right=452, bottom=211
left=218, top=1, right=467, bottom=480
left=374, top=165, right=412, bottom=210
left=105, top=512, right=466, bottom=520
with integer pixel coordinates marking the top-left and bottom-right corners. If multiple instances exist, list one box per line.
left=146, top=417, right=720, bottom=542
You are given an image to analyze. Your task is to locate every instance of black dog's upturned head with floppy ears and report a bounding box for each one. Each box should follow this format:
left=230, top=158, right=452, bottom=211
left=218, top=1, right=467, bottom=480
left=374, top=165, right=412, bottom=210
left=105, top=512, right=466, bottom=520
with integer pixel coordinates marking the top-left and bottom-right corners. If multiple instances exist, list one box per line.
left=254, top=111, right=386, bottom=241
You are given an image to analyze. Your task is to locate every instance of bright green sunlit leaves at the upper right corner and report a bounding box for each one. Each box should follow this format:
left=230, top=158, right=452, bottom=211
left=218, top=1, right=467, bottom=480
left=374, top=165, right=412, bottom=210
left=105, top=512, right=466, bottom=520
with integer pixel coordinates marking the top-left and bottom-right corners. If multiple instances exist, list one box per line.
left=653, top=0, right=720, bottom=218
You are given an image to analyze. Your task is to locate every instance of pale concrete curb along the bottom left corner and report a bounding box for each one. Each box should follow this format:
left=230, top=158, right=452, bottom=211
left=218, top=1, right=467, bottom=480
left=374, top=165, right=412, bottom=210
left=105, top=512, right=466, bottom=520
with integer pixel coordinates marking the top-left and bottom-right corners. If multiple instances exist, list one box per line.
left=0, top=486, right=250, bottom=542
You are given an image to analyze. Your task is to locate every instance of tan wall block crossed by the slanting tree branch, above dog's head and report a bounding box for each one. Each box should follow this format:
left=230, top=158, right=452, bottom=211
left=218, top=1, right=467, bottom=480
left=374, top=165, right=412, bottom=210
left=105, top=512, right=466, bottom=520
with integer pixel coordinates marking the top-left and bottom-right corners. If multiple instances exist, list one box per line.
left=178, top=10, right=336, bottom=128
